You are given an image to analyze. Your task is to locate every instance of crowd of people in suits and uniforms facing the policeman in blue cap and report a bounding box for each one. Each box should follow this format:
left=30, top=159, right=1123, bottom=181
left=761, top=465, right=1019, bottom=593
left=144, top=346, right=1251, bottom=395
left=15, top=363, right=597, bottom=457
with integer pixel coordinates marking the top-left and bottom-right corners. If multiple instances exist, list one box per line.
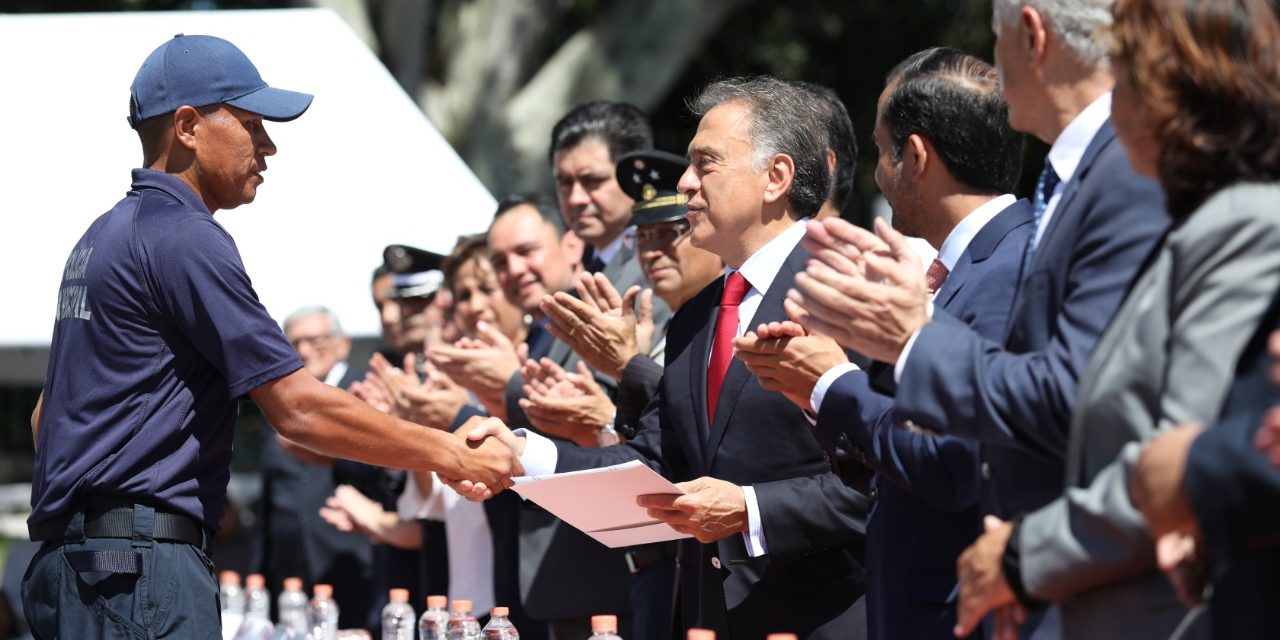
left=249, top=0, right=1280, bottom=640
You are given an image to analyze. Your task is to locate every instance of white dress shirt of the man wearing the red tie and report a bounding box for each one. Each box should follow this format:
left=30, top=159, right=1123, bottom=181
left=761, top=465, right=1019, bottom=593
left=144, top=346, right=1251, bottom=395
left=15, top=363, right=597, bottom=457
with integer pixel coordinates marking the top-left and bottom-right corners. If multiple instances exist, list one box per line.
left=516, top=218, right=809, bottom=558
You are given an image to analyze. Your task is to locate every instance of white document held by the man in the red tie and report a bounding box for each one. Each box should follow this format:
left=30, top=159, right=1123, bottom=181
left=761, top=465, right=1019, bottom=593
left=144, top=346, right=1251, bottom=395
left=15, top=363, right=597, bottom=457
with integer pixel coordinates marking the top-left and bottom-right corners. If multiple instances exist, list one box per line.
left=512, top=461, right=690, bottom=548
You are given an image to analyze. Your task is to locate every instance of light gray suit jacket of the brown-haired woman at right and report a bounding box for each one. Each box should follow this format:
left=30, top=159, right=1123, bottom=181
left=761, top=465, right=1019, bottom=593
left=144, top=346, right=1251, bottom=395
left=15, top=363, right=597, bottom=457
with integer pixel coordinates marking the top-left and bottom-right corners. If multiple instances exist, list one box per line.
left=1015, top=184, right=1280, bottom=639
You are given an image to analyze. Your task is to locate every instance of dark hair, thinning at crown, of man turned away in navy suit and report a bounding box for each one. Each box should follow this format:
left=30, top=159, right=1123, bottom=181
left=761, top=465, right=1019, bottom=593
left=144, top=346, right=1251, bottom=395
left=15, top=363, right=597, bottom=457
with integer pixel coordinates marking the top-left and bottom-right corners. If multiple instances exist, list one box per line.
left=881, top=47, right=1023, bottom=193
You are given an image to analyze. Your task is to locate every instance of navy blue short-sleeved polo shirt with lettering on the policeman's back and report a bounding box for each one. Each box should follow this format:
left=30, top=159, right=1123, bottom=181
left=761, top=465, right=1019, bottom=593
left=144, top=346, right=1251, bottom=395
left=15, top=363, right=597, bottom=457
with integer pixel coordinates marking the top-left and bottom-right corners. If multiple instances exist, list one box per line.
left=29, top=169, right=302, bottom=529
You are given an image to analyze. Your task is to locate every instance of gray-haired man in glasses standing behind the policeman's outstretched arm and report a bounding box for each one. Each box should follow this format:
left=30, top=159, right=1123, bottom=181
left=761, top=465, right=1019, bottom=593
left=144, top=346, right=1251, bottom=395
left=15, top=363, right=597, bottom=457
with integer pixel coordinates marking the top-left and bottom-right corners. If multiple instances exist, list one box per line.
left=253, top=307, right=371, bottom=627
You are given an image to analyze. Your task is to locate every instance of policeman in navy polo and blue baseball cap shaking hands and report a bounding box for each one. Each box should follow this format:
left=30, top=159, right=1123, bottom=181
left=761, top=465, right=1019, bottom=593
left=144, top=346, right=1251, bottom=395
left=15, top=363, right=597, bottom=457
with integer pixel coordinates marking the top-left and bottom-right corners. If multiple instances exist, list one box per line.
left=23, top=35, right=518, bottom=639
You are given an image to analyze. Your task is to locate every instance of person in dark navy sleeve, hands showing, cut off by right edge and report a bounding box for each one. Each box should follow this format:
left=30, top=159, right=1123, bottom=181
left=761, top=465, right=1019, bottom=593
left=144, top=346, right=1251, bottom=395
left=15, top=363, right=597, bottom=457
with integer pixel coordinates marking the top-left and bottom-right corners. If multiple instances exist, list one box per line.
left=1129, top=294, right=1280, bottom=637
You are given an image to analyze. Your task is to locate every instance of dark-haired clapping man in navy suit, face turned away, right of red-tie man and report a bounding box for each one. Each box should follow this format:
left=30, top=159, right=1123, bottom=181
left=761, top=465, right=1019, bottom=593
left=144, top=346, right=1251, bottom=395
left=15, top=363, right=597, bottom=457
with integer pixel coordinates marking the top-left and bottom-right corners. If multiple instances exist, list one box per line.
left=736, top=49, right=1032, bottom=639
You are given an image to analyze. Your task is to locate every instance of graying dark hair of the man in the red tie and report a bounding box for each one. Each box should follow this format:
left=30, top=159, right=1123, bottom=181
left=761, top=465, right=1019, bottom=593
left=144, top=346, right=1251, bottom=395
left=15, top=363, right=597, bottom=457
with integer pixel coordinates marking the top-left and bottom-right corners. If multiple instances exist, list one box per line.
left=690, top=76, right=831, bottom=215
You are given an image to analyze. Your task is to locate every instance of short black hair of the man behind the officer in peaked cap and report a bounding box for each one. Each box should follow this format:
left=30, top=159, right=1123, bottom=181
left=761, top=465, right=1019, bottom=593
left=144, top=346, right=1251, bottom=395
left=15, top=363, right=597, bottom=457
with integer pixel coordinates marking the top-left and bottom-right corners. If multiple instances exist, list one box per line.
left=549, top=100, right=653, bottom=161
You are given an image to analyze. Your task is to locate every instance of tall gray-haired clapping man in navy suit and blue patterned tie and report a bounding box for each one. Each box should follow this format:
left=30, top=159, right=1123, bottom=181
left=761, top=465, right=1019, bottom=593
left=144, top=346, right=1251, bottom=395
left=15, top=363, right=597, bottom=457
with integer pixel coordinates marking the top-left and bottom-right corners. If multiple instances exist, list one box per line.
left=778, top=0, right=1167, bottom=637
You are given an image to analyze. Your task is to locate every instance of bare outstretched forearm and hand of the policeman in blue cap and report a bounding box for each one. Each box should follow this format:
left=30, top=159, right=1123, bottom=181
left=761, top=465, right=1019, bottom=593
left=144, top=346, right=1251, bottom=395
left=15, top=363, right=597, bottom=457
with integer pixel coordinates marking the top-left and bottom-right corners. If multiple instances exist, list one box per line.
left=250, top=369, right=520, bottom=492
